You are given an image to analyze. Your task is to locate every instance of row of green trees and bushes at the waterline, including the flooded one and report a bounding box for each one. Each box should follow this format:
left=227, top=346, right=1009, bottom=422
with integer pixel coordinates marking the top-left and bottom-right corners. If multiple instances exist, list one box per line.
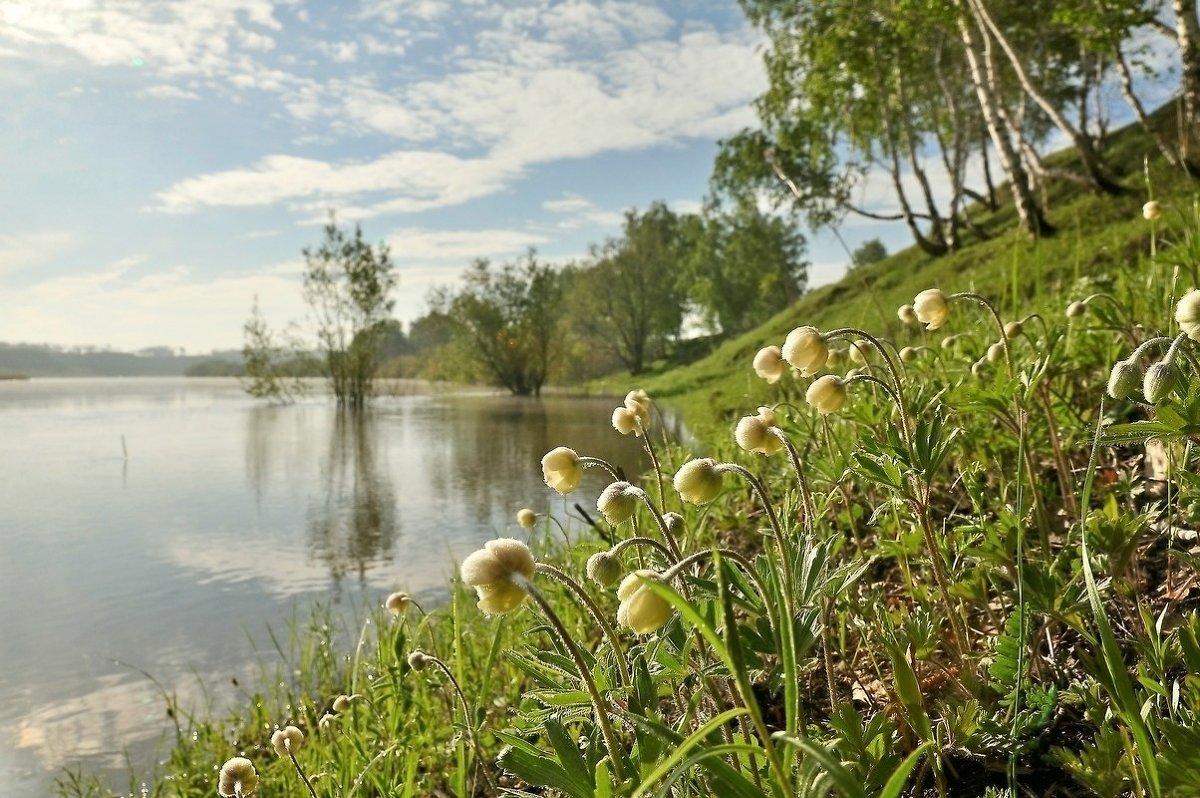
left=242, top=203, right=808, bottom=398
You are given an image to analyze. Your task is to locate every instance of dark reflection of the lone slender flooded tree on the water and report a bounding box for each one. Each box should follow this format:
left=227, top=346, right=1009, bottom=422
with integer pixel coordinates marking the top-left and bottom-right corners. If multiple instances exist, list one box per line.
left=307, top=410, right=396, bottom=593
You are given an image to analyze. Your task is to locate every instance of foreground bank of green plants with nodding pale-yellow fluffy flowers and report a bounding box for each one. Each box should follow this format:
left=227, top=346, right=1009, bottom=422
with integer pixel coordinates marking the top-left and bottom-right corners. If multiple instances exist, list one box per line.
left=64, top=192, right=1200, bottom=798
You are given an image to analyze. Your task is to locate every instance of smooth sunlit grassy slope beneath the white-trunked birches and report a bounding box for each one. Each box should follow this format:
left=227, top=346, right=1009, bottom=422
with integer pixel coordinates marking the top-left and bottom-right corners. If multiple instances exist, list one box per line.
left=628, top=113, right=1200, bottom=438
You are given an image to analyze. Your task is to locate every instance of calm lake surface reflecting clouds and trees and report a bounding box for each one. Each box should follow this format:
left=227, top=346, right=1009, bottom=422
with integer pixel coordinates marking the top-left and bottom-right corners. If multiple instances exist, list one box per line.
left=0, top=379, right=657, bottom=798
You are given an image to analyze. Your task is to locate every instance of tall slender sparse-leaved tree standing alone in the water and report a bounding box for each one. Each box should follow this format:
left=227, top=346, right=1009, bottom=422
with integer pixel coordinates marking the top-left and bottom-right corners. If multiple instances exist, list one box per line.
left=304, top=214, right=397, bottom=408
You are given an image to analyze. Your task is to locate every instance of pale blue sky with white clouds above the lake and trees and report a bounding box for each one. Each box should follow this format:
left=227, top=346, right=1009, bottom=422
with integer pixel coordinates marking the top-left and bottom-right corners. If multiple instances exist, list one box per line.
left=0, top=0, right=926, bottom=353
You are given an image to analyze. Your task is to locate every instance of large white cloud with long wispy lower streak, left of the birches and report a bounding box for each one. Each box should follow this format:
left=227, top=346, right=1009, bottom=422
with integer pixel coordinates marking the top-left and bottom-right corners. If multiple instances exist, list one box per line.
left=152, top=17, right=762, bottom=220
